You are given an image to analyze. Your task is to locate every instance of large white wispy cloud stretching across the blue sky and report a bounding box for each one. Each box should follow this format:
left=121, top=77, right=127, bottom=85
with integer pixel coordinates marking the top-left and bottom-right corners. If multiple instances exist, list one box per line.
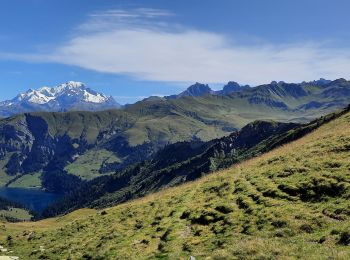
left=0, top=8, right=350, bottom=85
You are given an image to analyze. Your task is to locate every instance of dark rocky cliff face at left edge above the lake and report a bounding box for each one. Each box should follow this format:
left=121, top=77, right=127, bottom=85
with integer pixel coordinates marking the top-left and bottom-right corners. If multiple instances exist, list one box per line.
left=0, top=114, right=81, bottom=175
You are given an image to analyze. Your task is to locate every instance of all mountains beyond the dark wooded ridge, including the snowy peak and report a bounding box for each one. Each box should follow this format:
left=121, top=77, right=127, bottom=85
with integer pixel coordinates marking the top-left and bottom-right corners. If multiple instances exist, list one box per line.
left=0, top=79, right=350, bottom=191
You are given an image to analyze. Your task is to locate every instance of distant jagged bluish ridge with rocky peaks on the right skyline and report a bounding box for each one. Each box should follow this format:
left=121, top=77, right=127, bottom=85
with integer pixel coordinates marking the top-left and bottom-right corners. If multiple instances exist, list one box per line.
left=143, top=78, right=350, bottom=111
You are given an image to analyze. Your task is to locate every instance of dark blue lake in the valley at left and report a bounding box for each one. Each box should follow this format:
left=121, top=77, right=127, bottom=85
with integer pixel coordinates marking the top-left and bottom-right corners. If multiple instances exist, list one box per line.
left=0, top=187, right=63, bottom=213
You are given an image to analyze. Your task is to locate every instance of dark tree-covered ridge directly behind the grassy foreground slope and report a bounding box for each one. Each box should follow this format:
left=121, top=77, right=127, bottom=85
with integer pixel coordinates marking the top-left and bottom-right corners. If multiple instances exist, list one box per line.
left=43, top=121, right=298, bottom=217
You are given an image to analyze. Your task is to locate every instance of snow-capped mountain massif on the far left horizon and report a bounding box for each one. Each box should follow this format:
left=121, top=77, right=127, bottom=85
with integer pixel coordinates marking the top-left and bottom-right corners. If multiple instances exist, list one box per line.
left=0, top=81, right=120, bottom=117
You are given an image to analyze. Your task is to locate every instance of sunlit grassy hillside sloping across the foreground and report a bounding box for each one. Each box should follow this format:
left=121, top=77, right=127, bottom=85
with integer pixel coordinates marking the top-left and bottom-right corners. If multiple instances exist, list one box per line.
left=0, top=106, right=350, bottom=259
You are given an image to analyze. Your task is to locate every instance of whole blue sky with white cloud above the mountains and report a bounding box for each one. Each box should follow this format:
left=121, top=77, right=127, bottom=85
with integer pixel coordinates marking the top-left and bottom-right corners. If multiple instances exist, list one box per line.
left=0, top=0, right=350, bottom=103
